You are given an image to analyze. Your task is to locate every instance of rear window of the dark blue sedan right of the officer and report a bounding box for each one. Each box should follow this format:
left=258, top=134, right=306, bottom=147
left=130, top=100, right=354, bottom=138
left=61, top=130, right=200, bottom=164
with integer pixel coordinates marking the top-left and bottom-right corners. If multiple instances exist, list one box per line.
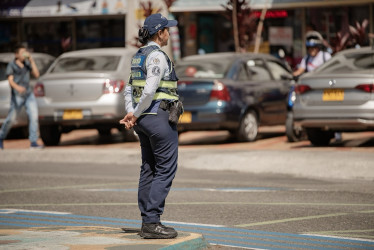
left=175, top=58, right=231, bottom=78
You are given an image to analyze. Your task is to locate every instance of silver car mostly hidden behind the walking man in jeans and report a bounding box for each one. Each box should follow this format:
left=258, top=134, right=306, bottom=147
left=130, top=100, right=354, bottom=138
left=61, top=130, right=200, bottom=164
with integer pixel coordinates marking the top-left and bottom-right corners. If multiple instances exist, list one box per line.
left=0, top=53, right=55, bottom=137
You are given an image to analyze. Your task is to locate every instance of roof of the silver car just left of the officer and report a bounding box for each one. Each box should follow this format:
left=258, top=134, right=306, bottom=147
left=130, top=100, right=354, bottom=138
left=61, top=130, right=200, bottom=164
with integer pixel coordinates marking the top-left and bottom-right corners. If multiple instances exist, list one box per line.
left=60, top=47, right=137, bottom=58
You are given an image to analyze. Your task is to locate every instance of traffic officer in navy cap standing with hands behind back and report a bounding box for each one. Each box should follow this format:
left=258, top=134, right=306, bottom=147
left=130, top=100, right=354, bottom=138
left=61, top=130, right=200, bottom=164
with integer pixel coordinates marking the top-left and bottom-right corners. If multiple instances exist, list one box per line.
left=120, top=13, right=179, bottom=239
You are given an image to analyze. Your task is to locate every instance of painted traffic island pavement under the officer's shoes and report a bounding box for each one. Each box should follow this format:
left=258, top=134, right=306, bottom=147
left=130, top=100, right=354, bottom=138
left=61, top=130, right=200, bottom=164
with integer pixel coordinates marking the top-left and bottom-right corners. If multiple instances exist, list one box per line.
left=0, top=226, right=209, bottom=250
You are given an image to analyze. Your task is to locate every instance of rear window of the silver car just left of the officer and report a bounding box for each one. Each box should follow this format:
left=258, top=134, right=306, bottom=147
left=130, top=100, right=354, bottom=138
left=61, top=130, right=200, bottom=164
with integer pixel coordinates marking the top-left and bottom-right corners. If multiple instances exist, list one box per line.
left=51, top=56, right=121, bottom=73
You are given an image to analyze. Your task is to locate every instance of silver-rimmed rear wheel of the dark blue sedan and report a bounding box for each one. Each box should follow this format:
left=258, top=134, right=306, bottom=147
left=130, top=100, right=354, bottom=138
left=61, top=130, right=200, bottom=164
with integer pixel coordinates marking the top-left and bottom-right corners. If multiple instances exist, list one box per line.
left=237, top=111, right=258, bottom=142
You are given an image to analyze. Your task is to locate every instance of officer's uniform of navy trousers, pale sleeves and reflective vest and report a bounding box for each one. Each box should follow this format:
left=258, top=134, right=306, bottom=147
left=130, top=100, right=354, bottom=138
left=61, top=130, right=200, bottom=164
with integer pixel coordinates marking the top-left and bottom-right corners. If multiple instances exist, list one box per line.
left=125, top=42, right=178, bottom=223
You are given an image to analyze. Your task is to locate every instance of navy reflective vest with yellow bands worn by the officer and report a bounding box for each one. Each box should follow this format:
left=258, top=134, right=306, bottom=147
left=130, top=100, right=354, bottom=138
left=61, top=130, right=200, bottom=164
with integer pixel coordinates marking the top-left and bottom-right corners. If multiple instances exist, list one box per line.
left=129, top=45, right=179, bottom=114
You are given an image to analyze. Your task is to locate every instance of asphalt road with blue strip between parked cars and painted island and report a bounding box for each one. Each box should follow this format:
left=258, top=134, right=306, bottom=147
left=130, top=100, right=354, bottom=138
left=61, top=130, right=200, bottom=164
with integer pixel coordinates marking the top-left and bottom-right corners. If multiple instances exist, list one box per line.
left=0, top=128, right=374, bottom=249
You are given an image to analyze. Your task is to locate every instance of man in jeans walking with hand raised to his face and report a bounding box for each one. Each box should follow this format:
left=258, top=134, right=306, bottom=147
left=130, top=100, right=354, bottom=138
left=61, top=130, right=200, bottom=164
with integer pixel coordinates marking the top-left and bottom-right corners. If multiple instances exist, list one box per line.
left=0, top=45, right=43, bottom=149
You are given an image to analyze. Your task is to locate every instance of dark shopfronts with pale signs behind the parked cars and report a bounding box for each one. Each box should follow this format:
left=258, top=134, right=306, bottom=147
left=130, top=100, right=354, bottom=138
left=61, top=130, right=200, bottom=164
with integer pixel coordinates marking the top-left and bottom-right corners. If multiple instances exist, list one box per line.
left=0, top=0, right=374, bottom=68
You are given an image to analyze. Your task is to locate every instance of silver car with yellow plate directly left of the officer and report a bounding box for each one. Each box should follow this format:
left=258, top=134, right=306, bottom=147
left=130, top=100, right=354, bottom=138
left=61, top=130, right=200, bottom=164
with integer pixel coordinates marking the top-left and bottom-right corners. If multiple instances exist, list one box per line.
left=34, top=48, right=136, bottom=146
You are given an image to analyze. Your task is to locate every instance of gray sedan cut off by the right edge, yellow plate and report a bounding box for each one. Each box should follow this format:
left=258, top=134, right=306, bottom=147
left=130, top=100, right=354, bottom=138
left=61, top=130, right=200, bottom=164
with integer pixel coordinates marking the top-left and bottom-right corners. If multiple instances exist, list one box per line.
left=293, top=47, right=374, bottom=146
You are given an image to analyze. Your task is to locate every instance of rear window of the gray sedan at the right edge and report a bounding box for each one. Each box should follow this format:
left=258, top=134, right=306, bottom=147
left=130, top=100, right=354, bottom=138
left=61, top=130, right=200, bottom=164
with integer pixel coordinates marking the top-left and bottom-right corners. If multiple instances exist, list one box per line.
left=316, top=51, right=374, bottom=73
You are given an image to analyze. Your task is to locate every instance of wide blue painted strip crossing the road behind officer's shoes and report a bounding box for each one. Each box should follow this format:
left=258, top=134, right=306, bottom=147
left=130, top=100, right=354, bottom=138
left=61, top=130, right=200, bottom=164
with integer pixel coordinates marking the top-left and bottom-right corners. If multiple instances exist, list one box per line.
left=0, top=209, right=374, bottom=250
